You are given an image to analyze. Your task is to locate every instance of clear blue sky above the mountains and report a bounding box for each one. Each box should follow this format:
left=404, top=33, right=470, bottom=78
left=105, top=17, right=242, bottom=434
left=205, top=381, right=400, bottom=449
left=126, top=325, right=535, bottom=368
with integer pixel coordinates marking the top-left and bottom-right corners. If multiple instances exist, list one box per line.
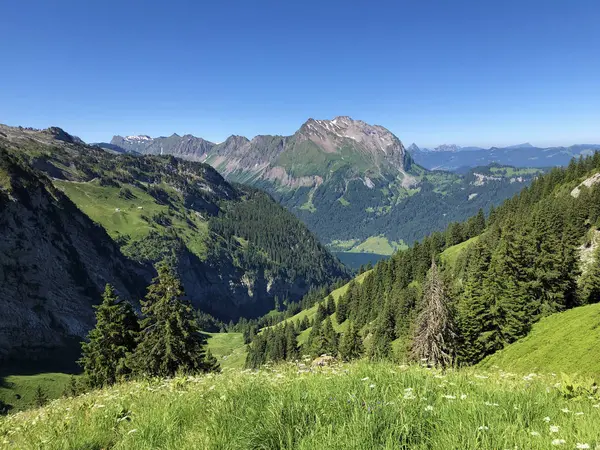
left=0, top=0, right=600, bottom=146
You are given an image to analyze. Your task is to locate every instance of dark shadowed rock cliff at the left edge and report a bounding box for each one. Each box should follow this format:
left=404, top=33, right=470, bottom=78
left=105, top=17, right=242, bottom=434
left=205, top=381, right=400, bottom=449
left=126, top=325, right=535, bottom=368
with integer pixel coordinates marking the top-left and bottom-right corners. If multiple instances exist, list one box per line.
left=0, top=148, right=142, bottom=361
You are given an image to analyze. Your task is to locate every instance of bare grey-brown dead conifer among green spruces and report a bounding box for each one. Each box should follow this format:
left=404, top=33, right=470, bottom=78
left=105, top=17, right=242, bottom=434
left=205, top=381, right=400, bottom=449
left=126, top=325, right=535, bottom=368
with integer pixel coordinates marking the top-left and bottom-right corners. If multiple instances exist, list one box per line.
left=411, top=260, right=456, bottom=367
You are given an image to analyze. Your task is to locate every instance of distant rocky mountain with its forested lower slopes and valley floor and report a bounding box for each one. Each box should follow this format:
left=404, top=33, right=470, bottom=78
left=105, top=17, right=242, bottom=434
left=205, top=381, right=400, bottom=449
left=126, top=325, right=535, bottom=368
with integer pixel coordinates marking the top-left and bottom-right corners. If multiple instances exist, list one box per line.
left=97, top=117, right=542, bottom=267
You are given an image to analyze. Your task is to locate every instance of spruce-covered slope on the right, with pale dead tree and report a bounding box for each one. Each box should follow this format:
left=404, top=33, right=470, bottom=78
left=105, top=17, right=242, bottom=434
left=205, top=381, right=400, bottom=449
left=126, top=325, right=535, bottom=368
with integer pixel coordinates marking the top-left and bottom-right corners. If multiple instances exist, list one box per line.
left=248, top=153, right=600, bottom=366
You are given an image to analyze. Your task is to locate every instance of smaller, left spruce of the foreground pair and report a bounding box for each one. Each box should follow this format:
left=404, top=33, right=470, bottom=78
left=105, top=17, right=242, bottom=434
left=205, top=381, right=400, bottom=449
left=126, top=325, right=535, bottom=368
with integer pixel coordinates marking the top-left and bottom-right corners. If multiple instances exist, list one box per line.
left=79, top=284, right=139, bottom=387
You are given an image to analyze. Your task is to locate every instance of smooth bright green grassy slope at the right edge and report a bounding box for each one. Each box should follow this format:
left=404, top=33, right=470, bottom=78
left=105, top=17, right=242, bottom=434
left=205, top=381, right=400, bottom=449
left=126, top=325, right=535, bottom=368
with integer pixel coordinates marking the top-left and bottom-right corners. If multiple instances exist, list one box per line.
left=480, top=304, right=600, bottom=380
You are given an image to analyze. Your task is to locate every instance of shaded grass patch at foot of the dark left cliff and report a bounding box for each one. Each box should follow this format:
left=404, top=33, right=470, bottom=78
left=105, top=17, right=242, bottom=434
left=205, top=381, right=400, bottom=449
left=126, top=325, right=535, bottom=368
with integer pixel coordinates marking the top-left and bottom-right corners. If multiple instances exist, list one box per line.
left=0, top=373, right=71, bottom=412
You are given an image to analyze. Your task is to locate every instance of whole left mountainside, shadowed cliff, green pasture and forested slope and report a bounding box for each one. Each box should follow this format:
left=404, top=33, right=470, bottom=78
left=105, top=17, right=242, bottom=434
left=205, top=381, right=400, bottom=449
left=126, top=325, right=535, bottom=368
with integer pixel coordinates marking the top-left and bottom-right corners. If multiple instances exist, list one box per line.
left=0, top=126, right=347, bottom=366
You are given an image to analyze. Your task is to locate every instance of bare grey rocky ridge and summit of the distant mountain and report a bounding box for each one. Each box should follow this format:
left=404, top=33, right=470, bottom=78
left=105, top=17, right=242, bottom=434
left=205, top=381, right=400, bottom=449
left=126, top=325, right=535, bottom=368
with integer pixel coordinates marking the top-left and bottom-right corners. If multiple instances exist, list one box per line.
left=111, top=116, right=412, bottom=187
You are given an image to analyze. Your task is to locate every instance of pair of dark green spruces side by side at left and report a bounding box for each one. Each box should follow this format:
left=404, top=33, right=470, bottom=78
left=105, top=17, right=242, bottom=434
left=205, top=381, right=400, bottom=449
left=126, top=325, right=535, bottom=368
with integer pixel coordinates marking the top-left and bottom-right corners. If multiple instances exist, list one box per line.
left=79, top=264, right=219, bottom=387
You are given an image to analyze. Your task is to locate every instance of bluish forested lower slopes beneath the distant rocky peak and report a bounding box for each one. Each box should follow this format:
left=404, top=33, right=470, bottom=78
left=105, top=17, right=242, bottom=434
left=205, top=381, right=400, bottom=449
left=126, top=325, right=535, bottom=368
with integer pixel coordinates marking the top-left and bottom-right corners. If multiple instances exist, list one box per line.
left=278, top=166, right=533, bottom=245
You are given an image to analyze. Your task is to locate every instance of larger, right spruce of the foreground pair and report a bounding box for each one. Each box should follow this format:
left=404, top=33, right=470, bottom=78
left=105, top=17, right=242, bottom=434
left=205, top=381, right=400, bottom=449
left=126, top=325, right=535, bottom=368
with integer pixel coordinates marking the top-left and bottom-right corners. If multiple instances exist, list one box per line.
left=131, top=264, right=207, bottom=377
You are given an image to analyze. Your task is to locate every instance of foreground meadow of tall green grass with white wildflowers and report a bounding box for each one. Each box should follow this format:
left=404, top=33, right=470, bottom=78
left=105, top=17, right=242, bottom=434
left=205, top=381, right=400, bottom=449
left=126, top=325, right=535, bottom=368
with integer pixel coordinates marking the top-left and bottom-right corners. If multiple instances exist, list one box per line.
left=0, top=362, right=600, bottom=450
